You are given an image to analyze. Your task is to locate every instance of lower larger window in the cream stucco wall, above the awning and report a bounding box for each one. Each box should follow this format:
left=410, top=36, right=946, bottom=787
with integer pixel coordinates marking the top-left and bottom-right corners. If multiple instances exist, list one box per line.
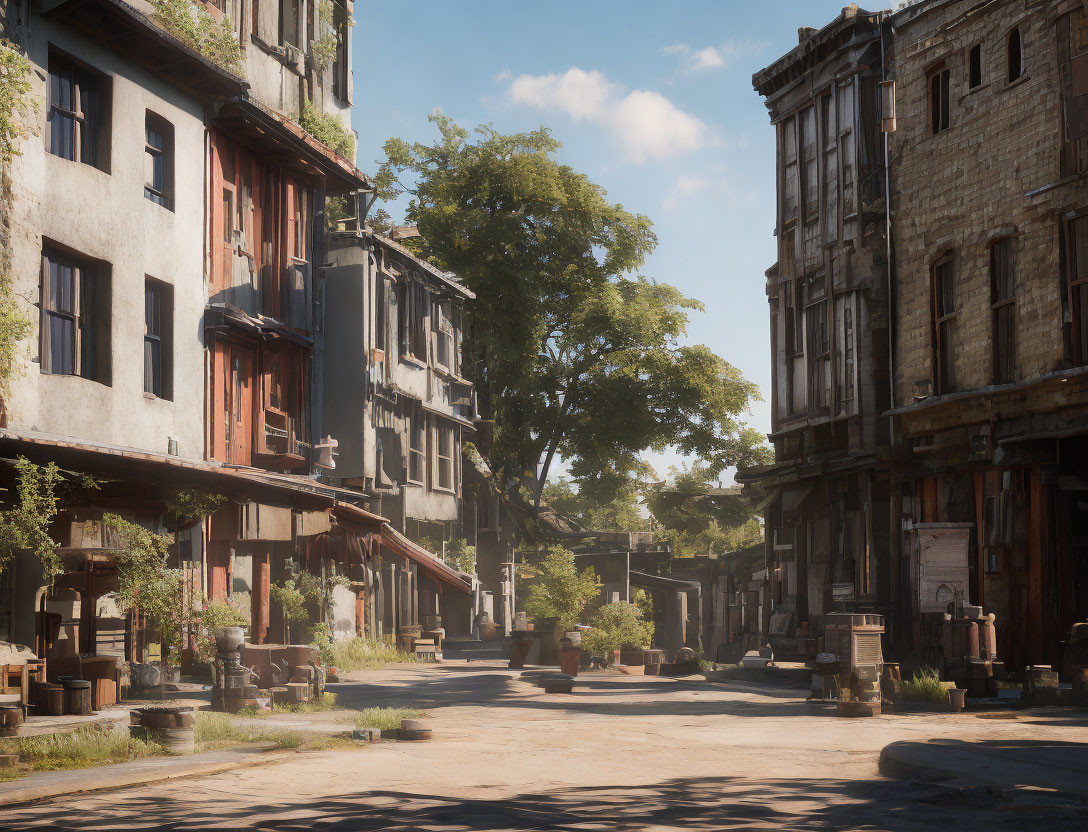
left=40, top=247, right=110, bottom=384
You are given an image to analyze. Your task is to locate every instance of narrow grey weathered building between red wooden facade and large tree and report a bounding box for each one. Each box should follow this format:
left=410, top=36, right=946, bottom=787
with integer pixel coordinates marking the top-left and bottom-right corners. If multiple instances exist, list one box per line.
left=323, top=224, right=475, bottom=632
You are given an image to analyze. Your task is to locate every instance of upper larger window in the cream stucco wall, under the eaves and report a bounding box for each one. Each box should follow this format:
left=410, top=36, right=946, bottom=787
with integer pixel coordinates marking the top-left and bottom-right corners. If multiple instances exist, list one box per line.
left=46, top=54, right=108, bottom=170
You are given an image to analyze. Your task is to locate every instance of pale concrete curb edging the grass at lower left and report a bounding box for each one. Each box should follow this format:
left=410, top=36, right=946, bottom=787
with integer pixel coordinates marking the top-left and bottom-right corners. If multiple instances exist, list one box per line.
left=0, top=748, right=297, bottom=806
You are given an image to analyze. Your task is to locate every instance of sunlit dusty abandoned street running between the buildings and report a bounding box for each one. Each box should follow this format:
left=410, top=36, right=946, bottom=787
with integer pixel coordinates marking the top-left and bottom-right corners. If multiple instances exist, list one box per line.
left=3, top=657, right=1088, bottom=832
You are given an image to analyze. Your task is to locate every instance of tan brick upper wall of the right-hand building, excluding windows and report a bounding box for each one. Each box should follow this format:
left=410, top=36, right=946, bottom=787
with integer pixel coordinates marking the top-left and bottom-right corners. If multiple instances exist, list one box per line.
left=891, top=0, right=1088, bottom=406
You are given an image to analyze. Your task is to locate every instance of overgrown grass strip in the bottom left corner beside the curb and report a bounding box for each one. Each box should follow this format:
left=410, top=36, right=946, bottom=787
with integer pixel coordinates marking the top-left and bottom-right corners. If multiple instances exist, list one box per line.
left=0, top=728, right=165, bottom=780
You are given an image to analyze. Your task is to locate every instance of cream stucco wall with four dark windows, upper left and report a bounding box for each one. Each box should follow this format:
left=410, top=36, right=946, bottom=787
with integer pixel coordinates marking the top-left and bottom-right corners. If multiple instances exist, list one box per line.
left=8, top=16, right=205, bottom=459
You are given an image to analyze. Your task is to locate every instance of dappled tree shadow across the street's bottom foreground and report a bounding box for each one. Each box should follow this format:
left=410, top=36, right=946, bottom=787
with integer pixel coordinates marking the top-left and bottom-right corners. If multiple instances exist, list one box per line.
left=4, top=777, right=1088, bottom=832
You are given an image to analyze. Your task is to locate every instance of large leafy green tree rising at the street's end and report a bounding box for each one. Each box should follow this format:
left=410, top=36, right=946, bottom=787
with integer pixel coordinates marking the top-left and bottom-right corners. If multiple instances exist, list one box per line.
left=376, top=114, right=765, bottom=505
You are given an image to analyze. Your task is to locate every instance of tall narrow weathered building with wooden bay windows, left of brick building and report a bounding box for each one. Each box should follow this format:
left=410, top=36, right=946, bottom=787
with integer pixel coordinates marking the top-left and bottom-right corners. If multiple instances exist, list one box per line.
left=738, top=5, right=891, bottom=650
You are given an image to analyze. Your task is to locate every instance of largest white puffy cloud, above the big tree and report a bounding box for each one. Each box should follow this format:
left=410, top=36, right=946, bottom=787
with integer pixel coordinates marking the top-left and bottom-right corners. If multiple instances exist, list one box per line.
left=500, top=66, right=714, bottom=163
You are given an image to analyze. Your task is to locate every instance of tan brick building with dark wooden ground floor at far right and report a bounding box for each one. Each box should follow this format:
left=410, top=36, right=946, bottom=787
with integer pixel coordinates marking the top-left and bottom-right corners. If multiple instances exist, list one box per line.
left=891, top=0, right=1088, bottom=669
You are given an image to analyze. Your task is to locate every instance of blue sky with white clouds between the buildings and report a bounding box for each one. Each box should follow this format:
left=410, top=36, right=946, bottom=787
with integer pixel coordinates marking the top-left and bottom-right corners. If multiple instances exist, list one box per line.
left=353, top=0, right=878, bottom=475
